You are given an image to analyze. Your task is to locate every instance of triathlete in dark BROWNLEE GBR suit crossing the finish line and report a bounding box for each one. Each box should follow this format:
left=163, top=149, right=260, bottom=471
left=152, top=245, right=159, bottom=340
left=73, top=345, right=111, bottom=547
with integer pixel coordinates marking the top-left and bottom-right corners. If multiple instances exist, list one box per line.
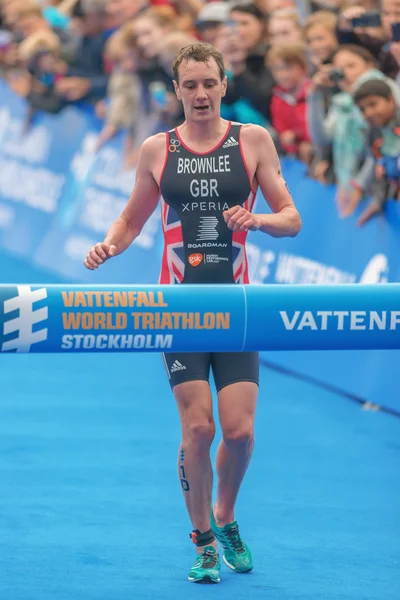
left=85, top=43, right=301, bottom=583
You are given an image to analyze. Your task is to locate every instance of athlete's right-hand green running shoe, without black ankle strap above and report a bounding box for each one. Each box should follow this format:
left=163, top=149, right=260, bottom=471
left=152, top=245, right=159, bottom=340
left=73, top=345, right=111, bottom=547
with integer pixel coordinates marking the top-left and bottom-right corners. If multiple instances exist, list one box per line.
left=211, top=511, right=253, bottom=573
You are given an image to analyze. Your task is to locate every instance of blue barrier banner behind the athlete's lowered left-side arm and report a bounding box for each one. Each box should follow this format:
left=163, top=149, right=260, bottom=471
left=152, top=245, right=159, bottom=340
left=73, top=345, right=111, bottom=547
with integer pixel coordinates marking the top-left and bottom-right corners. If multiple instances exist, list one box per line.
left=34, top=125, right=163, bottom=283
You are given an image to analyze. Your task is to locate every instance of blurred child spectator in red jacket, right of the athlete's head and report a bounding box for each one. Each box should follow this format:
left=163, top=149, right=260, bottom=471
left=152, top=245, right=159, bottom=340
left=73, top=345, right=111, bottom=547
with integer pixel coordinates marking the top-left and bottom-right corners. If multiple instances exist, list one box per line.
left=267, top=44, right=312, bottom=164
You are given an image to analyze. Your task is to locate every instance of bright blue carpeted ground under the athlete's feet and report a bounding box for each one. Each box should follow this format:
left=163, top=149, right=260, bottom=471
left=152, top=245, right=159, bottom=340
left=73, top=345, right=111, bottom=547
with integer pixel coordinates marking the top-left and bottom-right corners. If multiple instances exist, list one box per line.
left=0, top=257, right=400, bottom=600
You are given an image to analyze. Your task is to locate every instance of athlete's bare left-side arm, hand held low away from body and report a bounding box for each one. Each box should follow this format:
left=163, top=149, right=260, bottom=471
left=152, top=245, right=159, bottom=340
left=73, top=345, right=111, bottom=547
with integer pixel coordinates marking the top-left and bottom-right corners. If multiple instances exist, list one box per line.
left=84, top=134, right=165, bottom=271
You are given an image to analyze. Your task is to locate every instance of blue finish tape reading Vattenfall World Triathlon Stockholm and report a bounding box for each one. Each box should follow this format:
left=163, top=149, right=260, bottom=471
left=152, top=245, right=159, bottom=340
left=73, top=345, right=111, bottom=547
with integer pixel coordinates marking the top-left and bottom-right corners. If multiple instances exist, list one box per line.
left=0, top=284, right=400, bottom=353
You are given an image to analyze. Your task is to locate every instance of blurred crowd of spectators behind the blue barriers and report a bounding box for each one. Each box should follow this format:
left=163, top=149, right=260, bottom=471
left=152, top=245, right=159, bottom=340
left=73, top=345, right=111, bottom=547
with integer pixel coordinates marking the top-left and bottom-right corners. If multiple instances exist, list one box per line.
left=0, top=0, right=400, bottom=225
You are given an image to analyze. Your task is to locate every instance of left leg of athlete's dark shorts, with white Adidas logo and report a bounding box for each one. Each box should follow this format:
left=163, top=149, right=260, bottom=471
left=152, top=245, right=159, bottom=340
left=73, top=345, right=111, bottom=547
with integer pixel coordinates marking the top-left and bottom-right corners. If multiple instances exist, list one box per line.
left=162, top=352, right=211, bottom=388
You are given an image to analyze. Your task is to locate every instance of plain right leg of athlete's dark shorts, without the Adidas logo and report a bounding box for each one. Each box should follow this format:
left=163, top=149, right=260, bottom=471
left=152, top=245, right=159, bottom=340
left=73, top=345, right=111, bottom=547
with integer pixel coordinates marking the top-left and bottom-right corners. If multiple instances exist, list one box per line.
left=211, top=352, right=260, bottom=392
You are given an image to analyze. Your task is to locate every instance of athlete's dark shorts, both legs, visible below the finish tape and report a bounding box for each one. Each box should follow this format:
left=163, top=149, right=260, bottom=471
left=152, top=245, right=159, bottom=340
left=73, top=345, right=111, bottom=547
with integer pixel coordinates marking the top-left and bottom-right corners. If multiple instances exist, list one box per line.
left=162, top=352, right=260, bottom=392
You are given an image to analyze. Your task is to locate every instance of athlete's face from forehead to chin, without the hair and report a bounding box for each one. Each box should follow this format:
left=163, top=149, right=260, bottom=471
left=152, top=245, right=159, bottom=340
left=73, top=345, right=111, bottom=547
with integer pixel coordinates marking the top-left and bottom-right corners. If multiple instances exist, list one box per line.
left=174, top=58, right=226, bottom=121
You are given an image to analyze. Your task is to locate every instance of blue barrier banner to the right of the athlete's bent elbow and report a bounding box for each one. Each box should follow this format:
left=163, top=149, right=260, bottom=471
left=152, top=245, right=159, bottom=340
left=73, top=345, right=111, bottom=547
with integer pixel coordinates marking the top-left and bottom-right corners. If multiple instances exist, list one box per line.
left=247, top=161, right=400, bottom=284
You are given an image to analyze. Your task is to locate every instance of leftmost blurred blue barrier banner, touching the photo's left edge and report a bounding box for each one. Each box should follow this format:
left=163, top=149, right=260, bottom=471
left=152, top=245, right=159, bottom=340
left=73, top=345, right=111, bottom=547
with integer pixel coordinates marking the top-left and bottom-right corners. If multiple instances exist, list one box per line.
left=0, top=82, right=84, bottom=260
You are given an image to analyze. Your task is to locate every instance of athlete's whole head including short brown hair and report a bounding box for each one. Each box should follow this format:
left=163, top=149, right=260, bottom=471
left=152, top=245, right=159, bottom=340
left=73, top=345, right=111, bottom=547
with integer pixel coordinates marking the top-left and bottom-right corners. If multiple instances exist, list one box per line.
left=173, top=43, right=227, bottom=120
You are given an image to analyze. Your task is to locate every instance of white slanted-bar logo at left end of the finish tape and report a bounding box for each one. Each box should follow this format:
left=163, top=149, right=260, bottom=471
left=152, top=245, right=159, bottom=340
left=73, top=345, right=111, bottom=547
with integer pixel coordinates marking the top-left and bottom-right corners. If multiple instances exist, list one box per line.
left=0, top=285, right=48, bottom=352
